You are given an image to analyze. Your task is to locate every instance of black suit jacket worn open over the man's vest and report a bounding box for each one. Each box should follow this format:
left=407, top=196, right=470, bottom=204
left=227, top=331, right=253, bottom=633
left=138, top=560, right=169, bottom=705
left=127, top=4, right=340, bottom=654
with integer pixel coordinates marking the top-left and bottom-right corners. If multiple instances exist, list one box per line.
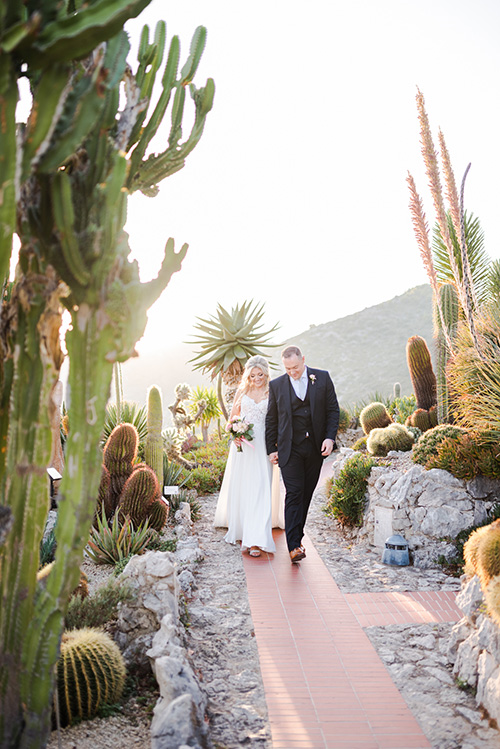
left=266, top=367, right=339, bottom=466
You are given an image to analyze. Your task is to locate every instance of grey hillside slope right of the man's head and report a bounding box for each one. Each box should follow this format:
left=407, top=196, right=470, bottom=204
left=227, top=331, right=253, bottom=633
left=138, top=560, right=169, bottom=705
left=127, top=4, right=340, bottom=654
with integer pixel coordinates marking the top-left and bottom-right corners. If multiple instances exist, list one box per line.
left=275, top=284, right=432, bottom=405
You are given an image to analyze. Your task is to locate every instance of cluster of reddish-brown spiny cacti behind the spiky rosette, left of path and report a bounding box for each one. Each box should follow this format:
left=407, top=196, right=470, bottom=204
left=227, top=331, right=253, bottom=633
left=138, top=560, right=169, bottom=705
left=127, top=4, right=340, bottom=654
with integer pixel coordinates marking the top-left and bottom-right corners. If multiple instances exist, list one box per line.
left=97, top=424, right=168, bottom=531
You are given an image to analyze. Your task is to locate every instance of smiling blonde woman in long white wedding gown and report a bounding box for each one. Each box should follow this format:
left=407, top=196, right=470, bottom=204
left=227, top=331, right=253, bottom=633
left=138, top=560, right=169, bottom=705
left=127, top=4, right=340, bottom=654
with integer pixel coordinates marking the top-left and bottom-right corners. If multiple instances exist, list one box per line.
left=214, top=355, right=285, bottom=557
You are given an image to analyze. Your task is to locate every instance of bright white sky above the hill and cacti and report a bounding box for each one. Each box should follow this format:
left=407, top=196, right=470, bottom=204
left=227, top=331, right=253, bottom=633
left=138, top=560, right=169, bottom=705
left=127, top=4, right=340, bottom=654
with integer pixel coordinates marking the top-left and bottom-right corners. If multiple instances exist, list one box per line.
left=120, top=0, right=500, bottom=352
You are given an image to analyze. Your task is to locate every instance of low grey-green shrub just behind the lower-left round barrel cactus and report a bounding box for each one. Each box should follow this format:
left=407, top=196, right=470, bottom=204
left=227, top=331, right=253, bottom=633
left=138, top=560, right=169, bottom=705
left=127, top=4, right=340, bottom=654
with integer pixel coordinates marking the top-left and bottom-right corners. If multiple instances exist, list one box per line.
left=64, top=579, right=133, bottom=629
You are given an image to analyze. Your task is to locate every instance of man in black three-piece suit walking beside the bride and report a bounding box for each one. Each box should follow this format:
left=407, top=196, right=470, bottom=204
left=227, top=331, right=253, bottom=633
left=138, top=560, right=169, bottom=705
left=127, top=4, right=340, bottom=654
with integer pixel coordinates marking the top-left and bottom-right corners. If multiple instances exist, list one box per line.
left=266, top=346, right=339, bottom=562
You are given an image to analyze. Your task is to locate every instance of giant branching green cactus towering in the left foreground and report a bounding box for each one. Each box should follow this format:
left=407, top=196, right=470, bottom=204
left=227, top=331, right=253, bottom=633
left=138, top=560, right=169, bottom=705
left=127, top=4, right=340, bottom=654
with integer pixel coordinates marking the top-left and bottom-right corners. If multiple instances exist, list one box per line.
left=0, top=0, right=214, bottom=747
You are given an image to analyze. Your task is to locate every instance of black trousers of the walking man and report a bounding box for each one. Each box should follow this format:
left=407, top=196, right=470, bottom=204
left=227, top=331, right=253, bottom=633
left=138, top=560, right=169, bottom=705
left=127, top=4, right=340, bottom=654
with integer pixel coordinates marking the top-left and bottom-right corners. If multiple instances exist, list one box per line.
left=281, top=439, right=323, bottom=551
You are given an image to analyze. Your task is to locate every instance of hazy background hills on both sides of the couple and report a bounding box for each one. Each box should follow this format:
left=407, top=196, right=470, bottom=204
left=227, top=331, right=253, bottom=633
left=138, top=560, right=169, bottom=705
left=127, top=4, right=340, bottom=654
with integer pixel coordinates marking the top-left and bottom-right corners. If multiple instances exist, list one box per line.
left=123, top=284, right=432, bottom=424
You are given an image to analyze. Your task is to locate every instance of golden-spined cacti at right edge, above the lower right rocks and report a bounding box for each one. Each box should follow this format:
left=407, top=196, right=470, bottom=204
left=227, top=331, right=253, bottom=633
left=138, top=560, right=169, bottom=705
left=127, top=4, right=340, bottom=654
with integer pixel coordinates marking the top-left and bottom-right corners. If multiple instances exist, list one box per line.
left=464, top=520, right=500, bottom=625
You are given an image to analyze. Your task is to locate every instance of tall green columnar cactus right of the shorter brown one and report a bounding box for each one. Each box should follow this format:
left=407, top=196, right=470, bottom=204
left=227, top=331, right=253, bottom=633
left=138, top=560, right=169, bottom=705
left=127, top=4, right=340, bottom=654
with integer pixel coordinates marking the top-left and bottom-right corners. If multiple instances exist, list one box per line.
left=434, top=283, right=460, bottom=424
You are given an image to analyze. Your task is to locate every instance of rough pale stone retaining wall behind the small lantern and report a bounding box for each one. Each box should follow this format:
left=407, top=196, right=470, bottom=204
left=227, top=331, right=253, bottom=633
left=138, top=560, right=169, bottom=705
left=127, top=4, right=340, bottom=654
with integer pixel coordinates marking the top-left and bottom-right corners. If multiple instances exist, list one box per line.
left=333, top=447, right=500, bottom=569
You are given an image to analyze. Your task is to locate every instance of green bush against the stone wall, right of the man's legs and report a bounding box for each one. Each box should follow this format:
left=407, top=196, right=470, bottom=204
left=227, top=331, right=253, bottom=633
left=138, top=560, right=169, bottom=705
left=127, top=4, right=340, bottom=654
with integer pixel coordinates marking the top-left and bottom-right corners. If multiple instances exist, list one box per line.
left=323, top=454, right=376, bottom=528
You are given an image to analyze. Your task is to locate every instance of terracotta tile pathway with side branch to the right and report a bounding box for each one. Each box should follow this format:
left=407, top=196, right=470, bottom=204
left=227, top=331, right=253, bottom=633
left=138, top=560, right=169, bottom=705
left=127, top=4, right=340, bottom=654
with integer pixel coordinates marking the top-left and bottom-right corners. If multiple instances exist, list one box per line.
left=243, top=531, right=459, bottom=749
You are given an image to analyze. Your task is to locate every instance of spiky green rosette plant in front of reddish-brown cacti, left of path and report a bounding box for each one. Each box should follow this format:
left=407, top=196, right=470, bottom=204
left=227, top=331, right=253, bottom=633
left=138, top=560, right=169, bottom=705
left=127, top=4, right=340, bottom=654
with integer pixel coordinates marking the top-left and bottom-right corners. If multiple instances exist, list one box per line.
left=86, top=509, right=154, bottom=565
